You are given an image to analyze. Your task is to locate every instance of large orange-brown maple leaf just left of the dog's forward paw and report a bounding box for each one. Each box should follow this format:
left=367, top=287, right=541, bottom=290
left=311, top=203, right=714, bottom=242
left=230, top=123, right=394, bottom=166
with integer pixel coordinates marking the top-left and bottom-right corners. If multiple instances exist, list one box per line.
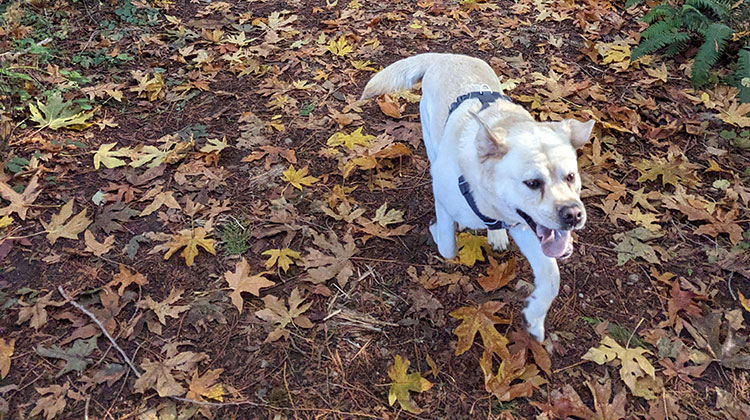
left=450, top=301, right=510, bottom=359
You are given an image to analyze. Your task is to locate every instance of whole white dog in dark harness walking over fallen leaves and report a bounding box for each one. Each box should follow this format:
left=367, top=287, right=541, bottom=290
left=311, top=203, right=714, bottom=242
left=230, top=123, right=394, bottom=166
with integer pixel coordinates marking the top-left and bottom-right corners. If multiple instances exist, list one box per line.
left=362, top=53, right=594, bottom=342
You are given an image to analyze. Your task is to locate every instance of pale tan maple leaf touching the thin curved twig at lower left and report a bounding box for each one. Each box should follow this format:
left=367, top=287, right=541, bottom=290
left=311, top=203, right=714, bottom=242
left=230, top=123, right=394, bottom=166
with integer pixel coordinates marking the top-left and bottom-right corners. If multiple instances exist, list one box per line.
left=134, top=351, right=208, bottom=397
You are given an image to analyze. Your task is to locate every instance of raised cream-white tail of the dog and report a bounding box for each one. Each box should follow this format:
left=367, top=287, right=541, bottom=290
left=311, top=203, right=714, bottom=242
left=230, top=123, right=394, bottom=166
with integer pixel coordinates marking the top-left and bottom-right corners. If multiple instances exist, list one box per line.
left=360, top=53, right=439, bottom=99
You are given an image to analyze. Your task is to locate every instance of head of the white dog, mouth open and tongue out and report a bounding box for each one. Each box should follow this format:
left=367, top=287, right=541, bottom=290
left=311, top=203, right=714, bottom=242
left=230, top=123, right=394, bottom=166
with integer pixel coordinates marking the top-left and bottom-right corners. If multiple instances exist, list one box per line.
left=474, top=114, right=594, bottom=258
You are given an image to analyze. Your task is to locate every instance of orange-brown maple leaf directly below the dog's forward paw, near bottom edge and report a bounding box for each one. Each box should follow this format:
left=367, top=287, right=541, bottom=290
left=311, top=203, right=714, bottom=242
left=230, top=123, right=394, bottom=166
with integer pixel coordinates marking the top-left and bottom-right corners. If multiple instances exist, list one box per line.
left=479, top=351, right=546, bottom=401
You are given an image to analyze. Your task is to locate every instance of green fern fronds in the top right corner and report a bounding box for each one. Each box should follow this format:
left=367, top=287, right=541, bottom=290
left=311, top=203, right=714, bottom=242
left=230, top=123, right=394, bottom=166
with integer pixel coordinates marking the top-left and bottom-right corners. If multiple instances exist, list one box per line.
left=625, top=0, right=750, bottom=102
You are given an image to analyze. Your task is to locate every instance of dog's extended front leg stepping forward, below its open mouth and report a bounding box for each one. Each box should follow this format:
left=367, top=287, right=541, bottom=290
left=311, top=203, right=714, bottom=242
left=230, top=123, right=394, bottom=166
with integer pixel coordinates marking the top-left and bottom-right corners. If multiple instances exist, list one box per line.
left=510, top=227, right=560, bottom=342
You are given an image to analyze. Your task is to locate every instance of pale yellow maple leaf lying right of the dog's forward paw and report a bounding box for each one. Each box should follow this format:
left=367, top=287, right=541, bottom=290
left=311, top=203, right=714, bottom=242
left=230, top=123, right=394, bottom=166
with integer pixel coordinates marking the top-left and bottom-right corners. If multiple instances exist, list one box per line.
left=583, top=335, right=656, bottom=394
